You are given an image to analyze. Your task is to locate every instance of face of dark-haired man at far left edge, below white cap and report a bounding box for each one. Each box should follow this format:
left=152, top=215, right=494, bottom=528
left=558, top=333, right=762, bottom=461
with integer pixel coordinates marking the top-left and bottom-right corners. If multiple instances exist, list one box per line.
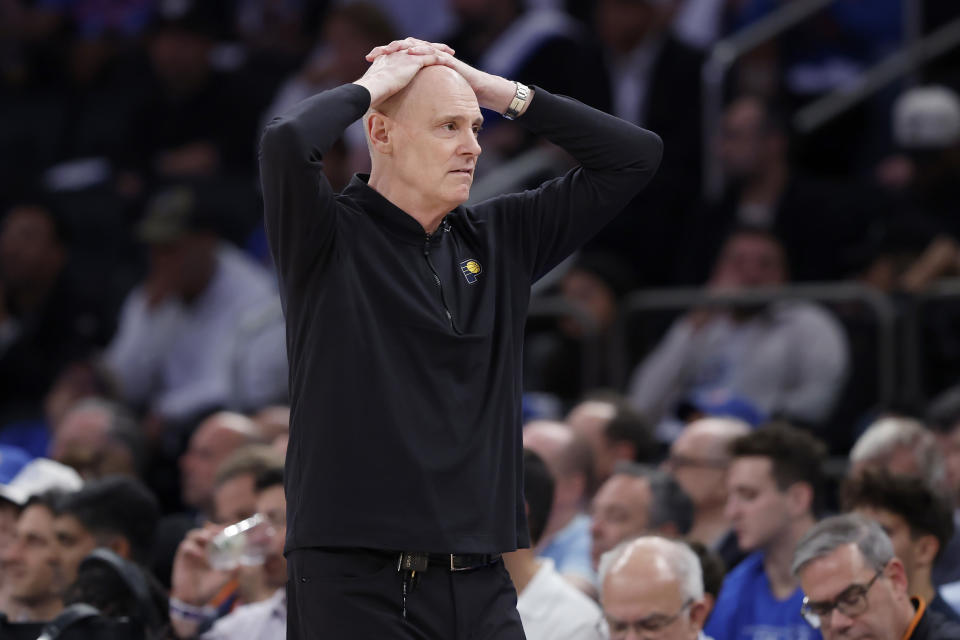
left=3, top=505, right=66, bottom=605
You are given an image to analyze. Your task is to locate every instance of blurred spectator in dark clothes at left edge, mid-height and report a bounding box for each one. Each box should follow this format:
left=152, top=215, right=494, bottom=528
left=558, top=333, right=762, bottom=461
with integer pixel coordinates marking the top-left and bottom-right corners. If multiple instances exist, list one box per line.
left=0, top=201, right=104, bottom=436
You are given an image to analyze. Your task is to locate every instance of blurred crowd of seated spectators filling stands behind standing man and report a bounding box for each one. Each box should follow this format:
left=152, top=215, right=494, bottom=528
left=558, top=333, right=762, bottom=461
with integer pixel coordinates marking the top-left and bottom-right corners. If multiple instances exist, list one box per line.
left=0, top=0, right=960, bottom=640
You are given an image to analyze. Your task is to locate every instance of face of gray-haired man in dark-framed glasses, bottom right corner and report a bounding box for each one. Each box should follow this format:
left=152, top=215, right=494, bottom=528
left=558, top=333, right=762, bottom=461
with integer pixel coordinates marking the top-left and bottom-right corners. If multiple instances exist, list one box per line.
left=799, top=544, right=909, bottom=640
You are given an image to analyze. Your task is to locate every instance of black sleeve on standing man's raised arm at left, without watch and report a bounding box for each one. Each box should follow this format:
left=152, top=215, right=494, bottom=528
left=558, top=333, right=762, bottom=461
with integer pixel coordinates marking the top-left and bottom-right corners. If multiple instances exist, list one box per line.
left=260, top=84, right=370, bottom=285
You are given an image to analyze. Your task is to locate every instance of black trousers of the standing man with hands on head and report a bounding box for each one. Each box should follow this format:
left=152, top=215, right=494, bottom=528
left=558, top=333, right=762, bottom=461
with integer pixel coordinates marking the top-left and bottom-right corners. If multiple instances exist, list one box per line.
left=287, top=548, right=525, bottom=640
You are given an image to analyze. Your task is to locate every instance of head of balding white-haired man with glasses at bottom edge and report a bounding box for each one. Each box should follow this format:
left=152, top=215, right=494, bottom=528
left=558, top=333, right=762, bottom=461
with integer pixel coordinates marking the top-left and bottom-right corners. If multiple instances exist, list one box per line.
left=597, top=536, right=710, bottom=640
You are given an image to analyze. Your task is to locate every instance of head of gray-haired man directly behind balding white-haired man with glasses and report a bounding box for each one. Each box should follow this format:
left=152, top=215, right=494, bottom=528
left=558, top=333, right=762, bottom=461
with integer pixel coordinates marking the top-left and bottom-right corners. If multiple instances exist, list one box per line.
left=590, top=463, right=693, bottom=567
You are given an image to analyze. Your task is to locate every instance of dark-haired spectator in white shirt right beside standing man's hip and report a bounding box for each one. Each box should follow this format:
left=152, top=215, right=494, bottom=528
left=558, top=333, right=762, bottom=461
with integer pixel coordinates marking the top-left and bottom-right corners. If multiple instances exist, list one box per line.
left=503, top=450, right=600, bottom=640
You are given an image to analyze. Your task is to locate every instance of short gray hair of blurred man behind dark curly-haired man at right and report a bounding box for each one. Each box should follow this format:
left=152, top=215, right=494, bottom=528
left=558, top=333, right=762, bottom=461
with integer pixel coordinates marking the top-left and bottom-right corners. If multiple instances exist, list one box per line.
left=850, top=416, right=946, bottom=492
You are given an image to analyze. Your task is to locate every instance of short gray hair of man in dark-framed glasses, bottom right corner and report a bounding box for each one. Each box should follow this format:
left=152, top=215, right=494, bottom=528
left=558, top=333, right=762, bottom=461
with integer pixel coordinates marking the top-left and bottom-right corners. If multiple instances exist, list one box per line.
left=792, top=513, right=894, bottom=575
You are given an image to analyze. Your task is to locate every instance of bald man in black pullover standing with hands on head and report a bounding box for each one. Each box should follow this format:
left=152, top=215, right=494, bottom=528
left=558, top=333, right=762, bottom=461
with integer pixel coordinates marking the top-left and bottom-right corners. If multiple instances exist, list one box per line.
left=260, top=39, right=662, bottom=640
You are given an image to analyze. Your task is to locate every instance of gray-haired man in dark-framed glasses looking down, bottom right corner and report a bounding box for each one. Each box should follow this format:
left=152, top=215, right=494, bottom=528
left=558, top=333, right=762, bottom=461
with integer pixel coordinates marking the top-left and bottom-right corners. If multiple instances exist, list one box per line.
left=793, top=513, right=960, bottom=640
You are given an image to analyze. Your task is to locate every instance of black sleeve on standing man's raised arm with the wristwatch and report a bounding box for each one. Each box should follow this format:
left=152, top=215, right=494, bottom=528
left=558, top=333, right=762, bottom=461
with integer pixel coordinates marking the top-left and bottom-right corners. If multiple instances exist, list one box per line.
left=475, top=87, right=663, bottom=280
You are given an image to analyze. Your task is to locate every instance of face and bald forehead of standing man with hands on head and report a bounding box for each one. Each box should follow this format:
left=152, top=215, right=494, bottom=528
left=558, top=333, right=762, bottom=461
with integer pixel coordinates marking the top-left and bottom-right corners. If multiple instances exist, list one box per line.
left=380, top=66, right=483, bottom=211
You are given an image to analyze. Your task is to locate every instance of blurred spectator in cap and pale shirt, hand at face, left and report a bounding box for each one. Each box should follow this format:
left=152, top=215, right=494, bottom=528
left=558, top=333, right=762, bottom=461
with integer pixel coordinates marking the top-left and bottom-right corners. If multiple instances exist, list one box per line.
left=106, top=186, right=286, bottom=437
